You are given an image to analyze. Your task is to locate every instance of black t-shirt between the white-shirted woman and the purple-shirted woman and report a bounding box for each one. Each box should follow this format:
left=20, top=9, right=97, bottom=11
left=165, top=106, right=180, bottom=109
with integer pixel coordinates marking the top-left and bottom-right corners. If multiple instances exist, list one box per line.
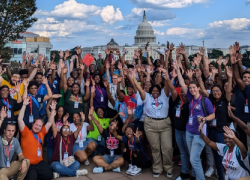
left=173, top=96, right=189, bottom=131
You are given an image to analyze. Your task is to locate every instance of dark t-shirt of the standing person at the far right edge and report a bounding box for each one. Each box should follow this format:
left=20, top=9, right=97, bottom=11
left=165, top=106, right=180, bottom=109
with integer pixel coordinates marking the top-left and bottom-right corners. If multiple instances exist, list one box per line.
left=235, top=85, right=250, bottom=122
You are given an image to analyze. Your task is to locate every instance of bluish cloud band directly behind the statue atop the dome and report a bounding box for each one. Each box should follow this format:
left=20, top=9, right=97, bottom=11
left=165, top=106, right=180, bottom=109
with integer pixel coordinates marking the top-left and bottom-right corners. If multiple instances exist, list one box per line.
left=126, top=8, right=176, bottom=22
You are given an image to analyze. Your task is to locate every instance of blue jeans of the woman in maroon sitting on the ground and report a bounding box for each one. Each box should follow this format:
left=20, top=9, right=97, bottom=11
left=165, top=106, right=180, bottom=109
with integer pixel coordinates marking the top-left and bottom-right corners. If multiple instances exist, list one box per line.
left=50, top=161, right=80, bottom=177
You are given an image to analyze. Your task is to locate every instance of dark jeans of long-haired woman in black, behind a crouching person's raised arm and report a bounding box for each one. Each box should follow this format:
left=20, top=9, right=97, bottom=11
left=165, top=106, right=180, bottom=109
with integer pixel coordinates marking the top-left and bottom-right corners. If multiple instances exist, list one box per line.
left=208, top=130, right=225, bottom=180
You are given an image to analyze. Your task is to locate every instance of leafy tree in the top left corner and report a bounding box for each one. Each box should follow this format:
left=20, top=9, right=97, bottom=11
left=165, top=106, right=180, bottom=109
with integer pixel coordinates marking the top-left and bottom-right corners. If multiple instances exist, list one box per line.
left=0, top=0, right=37, bottom=59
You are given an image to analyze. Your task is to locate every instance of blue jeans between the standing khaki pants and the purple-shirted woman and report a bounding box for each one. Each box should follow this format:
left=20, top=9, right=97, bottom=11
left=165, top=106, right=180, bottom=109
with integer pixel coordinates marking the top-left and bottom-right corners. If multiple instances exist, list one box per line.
left=175, top=129, right=189, bottom=174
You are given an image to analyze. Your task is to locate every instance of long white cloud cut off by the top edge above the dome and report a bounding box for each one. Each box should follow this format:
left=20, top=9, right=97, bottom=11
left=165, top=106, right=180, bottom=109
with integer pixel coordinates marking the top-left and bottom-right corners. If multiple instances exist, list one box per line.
left=129, top=0, right=209, bottom=9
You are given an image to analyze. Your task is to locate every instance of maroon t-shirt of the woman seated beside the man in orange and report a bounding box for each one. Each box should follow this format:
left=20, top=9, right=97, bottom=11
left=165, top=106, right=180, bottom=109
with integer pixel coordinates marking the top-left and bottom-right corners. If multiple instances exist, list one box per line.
left=50, top=132, right=76, bottom=163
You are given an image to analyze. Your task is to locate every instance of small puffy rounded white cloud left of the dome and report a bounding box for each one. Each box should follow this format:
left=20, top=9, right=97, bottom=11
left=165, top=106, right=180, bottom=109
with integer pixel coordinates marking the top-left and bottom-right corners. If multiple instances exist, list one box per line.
left=100, top=5, right=123, bottom=24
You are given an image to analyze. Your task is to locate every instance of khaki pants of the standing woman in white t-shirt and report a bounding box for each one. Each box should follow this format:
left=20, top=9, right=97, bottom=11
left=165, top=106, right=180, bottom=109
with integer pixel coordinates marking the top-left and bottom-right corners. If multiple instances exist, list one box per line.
left=144, top=117, right=173, bottom=173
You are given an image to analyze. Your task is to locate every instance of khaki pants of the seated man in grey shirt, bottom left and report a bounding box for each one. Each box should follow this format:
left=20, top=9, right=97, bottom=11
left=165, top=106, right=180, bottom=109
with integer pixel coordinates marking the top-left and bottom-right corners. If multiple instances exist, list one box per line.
left=0, top=159, right=30, bottom=180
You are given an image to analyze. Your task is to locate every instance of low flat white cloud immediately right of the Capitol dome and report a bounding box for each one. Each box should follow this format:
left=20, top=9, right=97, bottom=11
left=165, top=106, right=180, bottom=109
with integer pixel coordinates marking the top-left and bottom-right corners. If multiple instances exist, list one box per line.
left=166, top=27, right=205, bottom=39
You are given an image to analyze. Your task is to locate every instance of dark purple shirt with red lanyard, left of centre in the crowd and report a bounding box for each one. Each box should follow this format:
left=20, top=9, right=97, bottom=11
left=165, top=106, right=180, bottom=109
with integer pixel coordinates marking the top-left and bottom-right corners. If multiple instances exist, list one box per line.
left=89, top=85, right=108, bottom=110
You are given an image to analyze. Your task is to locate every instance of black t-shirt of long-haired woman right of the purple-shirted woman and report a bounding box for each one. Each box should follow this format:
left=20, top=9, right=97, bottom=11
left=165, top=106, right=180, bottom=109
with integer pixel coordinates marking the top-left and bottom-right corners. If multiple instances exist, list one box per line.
left=210, top=99, right=230, bottom=133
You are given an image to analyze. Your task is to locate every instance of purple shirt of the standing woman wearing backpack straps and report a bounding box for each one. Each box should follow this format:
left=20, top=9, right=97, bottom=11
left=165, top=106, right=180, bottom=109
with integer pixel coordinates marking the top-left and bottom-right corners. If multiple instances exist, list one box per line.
left=186, top=90, right=214, bottom=135
